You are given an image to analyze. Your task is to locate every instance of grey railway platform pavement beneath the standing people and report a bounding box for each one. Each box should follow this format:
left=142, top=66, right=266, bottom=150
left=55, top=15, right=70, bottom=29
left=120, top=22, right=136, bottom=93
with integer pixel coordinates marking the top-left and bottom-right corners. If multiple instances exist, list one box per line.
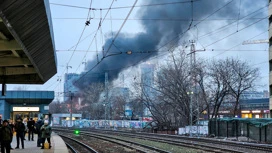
left=11, top=132, right=68, bottom=153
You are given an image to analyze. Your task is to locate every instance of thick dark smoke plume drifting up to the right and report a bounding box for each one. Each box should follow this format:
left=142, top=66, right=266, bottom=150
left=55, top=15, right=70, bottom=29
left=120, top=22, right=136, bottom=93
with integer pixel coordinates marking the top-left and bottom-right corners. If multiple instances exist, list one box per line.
left=75, top=0, right=264, bottom=87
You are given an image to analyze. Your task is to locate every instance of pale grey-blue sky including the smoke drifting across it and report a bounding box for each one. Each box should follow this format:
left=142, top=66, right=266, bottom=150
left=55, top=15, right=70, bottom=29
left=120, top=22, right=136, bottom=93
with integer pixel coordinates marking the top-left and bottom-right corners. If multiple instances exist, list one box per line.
left=8, top=0, right=269, bottom=98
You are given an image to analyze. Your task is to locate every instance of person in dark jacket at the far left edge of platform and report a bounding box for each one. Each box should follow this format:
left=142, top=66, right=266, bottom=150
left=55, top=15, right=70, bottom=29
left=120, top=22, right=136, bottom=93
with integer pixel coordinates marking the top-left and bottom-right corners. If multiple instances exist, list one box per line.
left=0, top=120, right=13, bottom=153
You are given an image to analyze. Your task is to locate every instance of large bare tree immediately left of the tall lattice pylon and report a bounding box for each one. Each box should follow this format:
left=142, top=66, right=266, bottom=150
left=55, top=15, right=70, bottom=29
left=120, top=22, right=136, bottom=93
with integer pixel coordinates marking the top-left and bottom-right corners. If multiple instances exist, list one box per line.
left=131, top=52, right=190, bottom=129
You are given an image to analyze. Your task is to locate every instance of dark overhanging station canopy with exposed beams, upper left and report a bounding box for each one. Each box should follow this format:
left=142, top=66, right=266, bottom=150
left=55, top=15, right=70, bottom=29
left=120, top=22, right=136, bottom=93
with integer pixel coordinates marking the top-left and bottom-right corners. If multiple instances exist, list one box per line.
left=0, top=0, right=57, bottom=84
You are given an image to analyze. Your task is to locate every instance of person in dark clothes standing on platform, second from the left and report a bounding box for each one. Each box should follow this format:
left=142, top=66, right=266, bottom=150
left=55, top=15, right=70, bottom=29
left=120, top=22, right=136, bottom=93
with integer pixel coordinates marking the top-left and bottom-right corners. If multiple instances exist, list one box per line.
left=15, top=118, right=25, bottom=149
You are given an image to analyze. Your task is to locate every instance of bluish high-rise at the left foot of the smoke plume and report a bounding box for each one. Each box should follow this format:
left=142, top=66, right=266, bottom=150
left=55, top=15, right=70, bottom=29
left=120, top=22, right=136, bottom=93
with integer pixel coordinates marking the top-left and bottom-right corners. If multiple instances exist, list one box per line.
left=63, top=73, right=80, bottom=101
